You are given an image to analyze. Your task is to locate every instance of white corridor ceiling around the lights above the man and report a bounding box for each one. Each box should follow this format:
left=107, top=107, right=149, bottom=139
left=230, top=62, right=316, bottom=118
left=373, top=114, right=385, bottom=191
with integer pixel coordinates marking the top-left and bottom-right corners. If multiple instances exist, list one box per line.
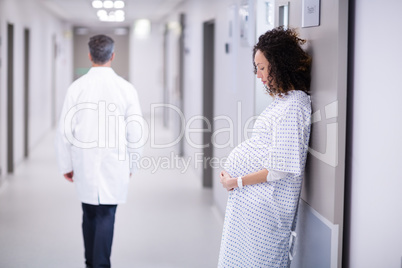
left=39, top=0, right=186, bottom=28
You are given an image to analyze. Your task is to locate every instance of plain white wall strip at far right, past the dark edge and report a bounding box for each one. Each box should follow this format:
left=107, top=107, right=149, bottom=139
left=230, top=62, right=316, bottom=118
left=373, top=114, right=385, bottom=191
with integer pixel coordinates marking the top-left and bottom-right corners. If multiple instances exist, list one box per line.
left=349, top=0, right=402, bottom=268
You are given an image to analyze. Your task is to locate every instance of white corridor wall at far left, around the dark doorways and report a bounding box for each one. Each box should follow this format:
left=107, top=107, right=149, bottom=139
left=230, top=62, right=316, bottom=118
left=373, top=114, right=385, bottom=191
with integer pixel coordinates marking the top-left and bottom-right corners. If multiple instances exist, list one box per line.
left=0, top=0, right=72, bottom=180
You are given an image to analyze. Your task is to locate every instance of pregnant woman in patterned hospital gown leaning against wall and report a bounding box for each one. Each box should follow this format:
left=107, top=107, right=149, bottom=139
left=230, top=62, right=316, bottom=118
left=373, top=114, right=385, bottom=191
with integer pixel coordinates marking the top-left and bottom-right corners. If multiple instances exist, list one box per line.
left=218, top=27, right=311, bottom=267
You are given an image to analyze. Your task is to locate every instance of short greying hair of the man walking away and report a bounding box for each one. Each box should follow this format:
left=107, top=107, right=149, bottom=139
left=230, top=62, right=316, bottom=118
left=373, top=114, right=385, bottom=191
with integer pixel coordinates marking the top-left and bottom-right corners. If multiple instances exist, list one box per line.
left=88, top=34, right=114, bottom=64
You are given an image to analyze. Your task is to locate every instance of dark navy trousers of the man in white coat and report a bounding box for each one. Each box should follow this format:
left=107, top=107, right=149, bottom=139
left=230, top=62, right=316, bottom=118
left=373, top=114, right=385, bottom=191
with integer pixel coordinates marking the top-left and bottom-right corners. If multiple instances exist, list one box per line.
left=82, top=203, right=117, bottom=268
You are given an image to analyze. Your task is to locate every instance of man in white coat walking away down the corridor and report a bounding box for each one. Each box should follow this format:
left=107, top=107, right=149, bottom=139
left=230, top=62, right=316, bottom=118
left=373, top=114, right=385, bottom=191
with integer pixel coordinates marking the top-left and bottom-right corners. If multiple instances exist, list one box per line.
left=55, top=35, right=144, bottom=268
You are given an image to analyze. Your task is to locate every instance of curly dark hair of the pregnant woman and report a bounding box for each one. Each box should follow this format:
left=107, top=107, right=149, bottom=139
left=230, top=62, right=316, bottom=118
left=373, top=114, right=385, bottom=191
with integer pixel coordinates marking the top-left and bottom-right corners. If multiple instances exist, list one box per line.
left=253, top=27, right=311, bottom=95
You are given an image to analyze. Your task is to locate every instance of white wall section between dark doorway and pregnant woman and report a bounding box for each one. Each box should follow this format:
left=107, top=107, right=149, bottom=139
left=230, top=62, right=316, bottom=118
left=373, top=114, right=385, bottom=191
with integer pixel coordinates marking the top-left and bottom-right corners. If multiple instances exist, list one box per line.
left=213, top=1, right=256, bottom=212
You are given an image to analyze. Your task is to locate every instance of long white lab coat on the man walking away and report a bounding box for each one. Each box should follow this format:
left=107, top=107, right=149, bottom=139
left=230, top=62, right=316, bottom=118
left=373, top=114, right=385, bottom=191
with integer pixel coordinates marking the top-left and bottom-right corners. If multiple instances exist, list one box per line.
left=55, top=67, right=147, bottom=205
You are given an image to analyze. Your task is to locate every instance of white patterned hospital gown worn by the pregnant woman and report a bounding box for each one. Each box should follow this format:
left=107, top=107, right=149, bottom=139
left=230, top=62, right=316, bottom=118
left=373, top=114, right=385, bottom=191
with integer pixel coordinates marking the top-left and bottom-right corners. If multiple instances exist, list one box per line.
left=218, top=90, right=311, bottom=268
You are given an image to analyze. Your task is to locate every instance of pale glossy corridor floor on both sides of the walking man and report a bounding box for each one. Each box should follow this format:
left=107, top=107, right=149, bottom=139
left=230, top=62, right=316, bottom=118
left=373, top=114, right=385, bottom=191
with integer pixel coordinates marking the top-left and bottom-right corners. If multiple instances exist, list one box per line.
left=0, top=126, right=223, bottom=268
